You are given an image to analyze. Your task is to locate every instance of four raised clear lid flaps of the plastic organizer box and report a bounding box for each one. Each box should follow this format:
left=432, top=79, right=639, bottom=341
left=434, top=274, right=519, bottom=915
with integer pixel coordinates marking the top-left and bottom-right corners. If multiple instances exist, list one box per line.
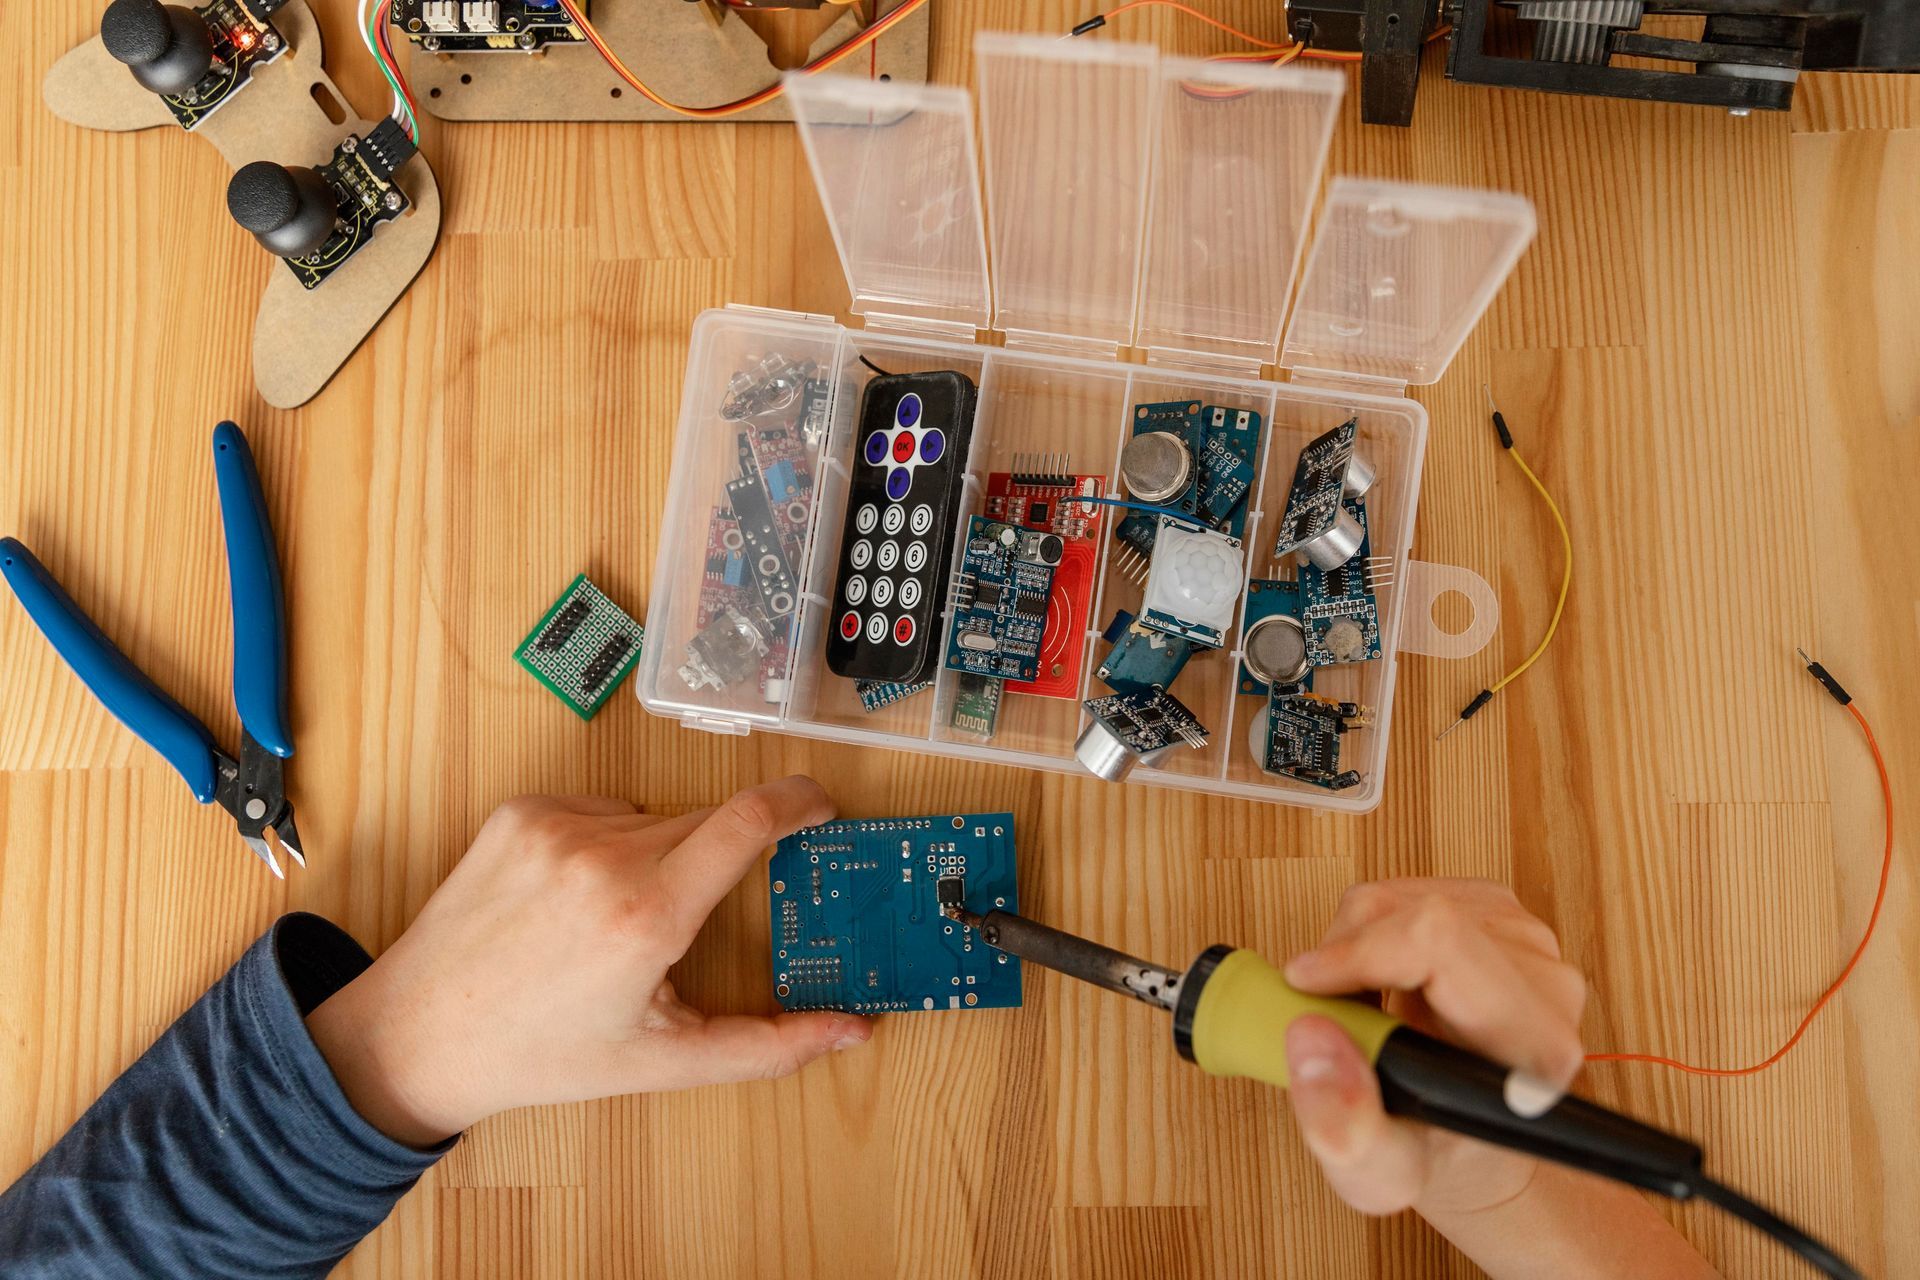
left=785, top=33, right=1534, bottom=390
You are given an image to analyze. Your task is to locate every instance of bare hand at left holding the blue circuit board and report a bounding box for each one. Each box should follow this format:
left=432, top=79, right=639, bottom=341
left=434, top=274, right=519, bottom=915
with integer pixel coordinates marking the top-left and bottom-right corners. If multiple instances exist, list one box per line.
left=307, top=777, right=874, bottom=1146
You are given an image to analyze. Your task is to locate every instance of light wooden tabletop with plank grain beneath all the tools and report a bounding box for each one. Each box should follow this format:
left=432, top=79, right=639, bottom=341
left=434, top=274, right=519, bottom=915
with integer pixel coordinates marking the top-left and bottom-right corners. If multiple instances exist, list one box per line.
left=0, top=0, right=1920, bottom=1280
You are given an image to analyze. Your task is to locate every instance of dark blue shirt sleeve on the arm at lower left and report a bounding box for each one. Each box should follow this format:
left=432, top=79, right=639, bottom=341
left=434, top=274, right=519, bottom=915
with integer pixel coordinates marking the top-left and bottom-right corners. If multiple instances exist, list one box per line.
left=0, top=913, right=453, bottom=1280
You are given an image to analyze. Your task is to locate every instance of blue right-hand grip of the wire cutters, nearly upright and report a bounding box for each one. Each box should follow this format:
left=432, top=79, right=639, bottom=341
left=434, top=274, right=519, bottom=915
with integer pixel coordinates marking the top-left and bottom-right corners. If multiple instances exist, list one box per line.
left=213, top=422, right=294, bottom=756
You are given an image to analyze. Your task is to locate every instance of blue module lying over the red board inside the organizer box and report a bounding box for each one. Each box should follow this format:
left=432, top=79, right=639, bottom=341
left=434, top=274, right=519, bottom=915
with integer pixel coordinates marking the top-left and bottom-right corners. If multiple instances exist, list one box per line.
left=947, top=516, right=1066, bottom=679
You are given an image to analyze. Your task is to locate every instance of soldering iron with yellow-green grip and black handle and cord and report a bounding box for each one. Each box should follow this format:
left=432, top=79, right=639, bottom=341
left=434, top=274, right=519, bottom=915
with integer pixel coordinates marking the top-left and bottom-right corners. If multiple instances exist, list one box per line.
left=943, top=900, right=1860, bottom=1280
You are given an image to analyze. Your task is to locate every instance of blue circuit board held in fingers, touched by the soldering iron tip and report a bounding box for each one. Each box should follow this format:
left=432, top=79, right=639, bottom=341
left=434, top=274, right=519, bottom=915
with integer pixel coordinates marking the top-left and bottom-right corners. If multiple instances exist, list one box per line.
left=768, top=814, right=1020, bottom=1013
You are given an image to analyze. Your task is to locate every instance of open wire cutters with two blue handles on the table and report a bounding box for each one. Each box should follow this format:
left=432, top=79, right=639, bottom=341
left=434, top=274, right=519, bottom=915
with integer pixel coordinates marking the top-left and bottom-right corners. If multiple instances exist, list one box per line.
left=0, top=422, right=307, bottom=879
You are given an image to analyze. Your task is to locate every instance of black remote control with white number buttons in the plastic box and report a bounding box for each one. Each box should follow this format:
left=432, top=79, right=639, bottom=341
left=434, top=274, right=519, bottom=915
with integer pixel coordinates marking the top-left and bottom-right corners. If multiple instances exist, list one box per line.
left=828, top=370, right=977, bottom=683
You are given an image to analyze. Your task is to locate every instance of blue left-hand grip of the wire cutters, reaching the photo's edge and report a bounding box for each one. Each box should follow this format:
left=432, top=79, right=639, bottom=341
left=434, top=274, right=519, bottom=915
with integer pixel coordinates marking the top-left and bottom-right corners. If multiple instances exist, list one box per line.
left=0, top=537, right=219, bottom=804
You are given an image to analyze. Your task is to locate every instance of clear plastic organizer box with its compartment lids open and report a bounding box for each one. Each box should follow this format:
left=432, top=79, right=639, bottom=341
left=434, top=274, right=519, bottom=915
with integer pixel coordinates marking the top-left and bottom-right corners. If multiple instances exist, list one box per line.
left=634, top=33, right=1534, bottom=812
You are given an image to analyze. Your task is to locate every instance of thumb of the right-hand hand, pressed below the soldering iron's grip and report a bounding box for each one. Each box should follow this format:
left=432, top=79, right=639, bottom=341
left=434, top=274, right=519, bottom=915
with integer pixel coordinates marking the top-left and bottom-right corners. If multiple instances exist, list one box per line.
left=1286, top=1013, right=1427, bottom=1213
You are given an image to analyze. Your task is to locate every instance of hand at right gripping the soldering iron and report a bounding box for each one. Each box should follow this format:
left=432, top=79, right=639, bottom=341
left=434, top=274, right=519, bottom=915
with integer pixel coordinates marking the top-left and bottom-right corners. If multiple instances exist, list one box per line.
left=1286, top=879, right=1586, bottom=1217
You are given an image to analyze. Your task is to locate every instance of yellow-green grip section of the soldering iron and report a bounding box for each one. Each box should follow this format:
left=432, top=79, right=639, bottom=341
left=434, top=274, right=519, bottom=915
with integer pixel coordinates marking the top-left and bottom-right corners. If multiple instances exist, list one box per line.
left=1173, top=946, right=1402, bottom=1088
